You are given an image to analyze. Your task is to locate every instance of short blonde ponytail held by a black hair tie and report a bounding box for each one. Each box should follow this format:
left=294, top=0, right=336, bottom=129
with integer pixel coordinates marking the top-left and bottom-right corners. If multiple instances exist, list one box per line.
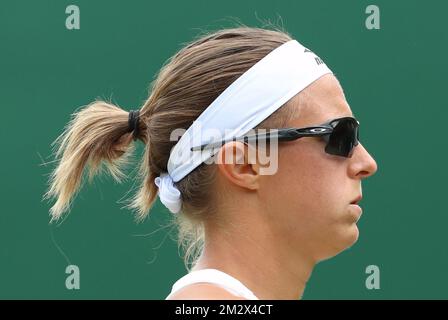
left=44, top=101, right=145, bottom=221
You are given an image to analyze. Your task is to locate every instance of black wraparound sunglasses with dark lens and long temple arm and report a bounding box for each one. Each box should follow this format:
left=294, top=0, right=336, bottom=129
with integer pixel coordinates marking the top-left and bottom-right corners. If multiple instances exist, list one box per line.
left=191, top=117, right=359, bottom=158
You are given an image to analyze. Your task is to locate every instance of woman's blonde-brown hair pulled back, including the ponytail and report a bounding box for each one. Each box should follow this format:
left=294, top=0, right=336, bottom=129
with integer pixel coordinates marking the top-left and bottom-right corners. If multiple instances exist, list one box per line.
left=44, top=26, right=297, bottom=269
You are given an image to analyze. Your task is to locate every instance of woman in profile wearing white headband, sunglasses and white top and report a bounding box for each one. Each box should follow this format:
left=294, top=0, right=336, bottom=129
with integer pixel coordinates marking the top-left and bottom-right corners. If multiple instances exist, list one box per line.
left=46, top=26, right=377, bottom=299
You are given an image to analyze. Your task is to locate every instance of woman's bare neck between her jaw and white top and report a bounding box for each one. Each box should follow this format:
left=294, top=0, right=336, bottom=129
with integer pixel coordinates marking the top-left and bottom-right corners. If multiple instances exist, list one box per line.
left=192, top=214, right=315, bottom=300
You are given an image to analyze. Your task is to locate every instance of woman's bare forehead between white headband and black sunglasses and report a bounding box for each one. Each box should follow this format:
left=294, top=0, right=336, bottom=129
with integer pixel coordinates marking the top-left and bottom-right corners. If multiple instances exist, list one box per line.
left=291, top=74, right=353, bottom=126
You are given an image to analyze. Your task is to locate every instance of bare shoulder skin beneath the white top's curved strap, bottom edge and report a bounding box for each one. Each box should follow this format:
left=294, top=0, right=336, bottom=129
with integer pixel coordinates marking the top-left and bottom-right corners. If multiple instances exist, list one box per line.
left=167, top=283, right=246, bottom=300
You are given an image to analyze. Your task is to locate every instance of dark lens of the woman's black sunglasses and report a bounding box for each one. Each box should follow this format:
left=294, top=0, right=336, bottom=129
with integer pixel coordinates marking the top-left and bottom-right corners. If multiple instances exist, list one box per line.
left=325, top=119, right=359, bottom=158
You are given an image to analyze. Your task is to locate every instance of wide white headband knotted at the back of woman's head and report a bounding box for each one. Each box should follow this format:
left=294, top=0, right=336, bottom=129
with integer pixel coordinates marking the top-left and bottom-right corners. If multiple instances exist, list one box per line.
left=154, top=40, right=332, bottom=213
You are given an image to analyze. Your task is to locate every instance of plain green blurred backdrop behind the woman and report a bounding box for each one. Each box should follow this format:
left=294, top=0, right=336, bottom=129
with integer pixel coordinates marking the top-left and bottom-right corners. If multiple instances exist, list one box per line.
left=0, top=0, right=448, bottom=299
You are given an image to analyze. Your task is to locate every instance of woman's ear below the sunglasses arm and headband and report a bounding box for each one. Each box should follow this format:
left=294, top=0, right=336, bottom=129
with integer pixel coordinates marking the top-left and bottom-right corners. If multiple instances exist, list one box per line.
left=216, top=141, right=260, bottom=190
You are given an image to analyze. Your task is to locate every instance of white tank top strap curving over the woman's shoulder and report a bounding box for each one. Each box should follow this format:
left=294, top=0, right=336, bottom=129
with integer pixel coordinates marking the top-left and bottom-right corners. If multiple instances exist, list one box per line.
left=165, top=269, right=259, bottom=300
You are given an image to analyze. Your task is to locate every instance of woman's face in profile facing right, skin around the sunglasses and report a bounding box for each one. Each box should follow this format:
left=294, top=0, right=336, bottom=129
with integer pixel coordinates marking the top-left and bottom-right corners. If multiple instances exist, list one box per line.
left=259, top=75, right=377, bottom=262
